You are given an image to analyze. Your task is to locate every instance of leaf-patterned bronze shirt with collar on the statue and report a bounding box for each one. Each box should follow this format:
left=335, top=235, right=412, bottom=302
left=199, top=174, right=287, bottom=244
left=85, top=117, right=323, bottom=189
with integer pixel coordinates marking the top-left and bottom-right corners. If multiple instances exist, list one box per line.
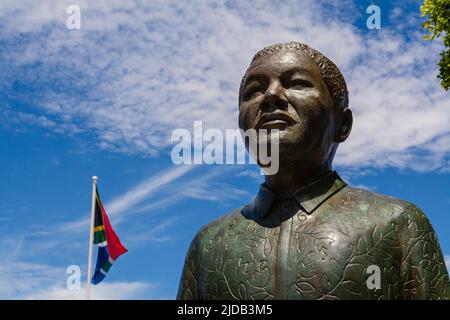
left=177, top=172, right=450, bottom=300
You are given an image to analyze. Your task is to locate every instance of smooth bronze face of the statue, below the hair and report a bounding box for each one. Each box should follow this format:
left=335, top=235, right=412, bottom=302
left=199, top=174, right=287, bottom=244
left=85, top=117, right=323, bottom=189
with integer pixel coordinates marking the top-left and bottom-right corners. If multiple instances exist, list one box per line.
left=239, top=49, right=336, bottom=170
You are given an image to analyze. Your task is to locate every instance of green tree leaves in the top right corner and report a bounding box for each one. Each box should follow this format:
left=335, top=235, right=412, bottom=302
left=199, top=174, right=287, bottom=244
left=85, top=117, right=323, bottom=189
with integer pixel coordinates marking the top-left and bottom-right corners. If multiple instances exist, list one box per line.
left=420, top=0, right=450, bottom=90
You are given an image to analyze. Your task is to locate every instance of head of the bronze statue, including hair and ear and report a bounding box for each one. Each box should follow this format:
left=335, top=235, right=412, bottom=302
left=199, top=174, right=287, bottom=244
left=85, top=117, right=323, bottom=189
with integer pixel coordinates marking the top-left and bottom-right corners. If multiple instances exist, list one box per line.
left=239, top=42, right=352, bottom=176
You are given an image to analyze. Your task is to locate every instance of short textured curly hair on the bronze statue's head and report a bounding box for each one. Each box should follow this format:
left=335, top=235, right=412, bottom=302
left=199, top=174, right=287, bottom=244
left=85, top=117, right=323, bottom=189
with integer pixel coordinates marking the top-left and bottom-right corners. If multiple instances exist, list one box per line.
left=239, top=42, right=348, bottom=108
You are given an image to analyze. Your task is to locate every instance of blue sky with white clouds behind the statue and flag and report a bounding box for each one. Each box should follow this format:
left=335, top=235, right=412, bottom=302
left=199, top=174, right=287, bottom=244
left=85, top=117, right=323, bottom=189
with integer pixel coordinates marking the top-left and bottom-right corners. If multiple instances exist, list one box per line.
left=0, top=0, right=450, bottom=299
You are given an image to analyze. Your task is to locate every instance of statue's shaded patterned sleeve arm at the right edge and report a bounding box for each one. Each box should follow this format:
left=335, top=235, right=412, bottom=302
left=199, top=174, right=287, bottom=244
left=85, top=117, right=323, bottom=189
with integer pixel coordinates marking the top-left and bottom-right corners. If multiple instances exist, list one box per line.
left=400, top=206, right=450, bottom=300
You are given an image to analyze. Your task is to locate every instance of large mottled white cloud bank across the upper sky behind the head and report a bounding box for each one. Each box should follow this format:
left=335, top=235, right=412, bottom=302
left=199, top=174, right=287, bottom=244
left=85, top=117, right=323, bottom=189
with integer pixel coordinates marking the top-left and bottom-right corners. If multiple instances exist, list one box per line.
left=0, top=1, right=450, bottom=170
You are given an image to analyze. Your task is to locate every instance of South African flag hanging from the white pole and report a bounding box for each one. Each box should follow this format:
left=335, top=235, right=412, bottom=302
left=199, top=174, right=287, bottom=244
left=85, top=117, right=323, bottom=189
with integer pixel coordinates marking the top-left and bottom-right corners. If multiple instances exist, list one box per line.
left=92, top=188, right=128, bottom=284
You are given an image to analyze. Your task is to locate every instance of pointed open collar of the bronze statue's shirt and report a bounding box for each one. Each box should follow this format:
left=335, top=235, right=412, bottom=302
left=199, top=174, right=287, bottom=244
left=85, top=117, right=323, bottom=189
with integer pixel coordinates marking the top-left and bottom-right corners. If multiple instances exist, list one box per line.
left=241, top=171, right=347, bottom=221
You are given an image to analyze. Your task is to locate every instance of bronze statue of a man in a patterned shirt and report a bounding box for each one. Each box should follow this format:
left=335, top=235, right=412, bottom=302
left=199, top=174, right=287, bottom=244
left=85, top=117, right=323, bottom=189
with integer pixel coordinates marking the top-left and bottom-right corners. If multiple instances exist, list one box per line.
left=177, top=42, right=450, bottom=299
